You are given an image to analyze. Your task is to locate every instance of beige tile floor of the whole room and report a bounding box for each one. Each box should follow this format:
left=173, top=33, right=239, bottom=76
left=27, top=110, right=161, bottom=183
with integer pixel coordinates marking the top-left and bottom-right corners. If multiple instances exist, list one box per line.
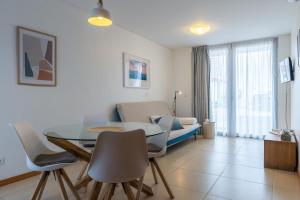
left=0, top=137, right=300, bottom=200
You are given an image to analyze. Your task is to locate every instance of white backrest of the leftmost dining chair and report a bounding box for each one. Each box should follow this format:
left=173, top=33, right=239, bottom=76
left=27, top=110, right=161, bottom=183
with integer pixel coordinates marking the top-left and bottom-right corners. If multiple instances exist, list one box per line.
left=9, top=123, right=49, bottom=162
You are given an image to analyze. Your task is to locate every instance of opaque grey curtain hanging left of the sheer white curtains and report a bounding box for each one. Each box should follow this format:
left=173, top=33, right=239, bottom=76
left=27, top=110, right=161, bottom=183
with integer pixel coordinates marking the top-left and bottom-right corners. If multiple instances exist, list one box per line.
left=192, top=46, right=210, bottom=124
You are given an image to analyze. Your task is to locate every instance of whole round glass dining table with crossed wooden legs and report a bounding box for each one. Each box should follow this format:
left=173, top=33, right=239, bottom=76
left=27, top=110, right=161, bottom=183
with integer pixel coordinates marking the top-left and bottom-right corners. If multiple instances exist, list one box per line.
left=43, top=122, right=167, bottom=195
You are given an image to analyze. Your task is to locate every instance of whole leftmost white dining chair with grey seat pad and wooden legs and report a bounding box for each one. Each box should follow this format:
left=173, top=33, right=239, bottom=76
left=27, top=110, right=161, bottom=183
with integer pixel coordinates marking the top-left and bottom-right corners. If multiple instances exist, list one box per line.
left=9, top=123, right=80, bottom=200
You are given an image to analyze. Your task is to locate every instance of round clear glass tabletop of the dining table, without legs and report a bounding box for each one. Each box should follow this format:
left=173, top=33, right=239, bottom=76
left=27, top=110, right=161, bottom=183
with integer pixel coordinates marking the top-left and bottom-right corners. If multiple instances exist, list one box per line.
left=43, top=122, right=167, bottom=141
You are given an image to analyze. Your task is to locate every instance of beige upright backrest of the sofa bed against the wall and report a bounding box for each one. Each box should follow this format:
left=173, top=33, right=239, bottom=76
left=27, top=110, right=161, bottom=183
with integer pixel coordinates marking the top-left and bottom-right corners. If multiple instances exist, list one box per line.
left=117, top=101, right=172, bottom=123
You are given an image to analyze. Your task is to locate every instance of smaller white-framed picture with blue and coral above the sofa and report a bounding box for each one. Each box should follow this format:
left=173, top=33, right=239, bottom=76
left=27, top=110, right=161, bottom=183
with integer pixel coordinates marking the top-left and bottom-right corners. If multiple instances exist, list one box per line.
left=123, top=53, right=150, bottom=88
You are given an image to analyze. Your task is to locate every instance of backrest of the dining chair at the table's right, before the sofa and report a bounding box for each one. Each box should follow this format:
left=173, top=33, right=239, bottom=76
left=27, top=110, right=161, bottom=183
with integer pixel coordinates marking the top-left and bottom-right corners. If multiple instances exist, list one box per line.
left=148, top=115, right=174, bottom=154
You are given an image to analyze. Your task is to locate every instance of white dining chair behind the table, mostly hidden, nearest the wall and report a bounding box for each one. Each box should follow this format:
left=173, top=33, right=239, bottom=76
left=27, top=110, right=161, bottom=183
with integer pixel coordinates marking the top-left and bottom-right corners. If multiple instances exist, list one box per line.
left=77, top=113, right=108, bottom=181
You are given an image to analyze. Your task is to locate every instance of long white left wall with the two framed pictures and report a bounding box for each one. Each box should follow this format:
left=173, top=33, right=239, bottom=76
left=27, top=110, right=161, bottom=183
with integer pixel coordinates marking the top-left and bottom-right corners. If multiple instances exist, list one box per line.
left=0, top=0, right=173, bottom=179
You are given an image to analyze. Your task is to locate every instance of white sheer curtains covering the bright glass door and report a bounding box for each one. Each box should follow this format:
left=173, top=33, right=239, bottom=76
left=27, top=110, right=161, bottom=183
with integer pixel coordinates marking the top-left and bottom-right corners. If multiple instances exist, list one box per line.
left=209, top=39, right=277, bottom=138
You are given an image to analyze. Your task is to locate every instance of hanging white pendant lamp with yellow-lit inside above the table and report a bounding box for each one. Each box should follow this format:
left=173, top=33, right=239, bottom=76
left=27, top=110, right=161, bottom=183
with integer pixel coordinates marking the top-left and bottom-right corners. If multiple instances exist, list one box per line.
left=88, top=0, right=112, bottom=26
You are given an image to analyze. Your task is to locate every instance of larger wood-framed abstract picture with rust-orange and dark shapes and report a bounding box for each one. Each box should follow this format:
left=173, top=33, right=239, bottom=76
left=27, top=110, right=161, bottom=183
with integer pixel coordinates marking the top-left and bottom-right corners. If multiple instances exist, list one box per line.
left=17, top=27, right=56, bottom=87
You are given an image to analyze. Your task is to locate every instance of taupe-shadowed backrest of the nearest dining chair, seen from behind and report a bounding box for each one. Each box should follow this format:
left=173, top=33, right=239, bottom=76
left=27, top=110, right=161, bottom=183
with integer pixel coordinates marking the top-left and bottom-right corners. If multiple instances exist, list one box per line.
left=88, top=130, right=148, bottom=183
